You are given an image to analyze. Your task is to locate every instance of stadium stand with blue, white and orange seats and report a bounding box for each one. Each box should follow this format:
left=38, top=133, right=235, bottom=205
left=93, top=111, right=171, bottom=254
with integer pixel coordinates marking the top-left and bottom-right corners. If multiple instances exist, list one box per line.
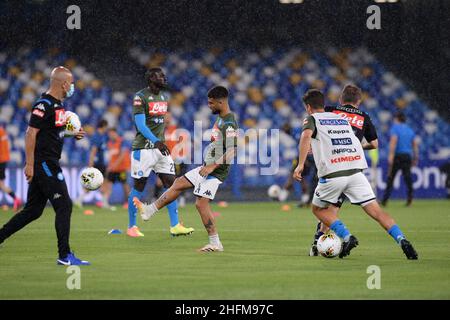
left=0, top=47, right=450, bottom=191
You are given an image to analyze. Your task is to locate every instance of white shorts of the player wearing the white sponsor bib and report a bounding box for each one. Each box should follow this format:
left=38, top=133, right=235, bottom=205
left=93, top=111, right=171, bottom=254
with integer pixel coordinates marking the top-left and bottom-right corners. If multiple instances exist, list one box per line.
left=312, top=172, right=376, bottom=208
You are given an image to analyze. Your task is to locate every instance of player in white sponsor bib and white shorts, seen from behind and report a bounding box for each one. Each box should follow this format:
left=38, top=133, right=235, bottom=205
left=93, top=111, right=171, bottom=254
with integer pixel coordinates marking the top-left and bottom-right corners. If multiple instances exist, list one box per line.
left=294, top=89, right=418, bottom=260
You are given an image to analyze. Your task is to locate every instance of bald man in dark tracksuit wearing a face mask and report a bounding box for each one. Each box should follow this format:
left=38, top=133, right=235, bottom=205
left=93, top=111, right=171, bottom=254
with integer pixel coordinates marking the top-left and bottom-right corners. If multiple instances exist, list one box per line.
left=0, top=67, right=89, bottom=265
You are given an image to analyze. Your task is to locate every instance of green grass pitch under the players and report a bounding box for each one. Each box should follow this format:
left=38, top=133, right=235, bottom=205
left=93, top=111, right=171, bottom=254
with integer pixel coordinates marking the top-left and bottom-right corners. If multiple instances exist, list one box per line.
left=0, top=200, right=450, bottom=299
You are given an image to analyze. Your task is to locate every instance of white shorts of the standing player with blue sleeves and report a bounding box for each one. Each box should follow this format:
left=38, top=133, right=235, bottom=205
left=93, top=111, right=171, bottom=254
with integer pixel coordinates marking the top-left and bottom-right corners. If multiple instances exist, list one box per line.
left=131, top=149, right=175, bottom=179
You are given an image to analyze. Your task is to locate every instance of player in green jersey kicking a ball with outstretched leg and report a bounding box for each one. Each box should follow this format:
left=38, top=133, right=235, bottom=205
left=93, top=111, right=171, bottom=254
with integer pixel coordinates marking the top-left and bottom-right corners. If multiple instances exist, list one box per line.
left=133, top=86, right=238, bottom=252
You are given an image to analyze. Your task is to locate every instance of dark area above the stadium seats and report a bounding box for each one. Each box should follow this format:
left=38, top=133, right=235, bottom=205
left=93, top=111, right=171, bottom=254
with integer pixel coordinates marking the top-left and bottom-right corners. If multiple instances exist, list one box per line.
left=0, top=0, right=450, bottom=119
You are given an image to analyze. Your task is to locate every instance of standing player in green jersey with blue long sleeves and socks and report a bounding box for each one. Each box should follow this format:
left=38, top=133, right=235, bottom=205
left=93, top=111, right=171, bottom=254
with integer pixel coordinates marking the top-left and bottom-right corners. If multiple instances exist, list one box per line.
left=127, top=68, right=194, bottom=237
